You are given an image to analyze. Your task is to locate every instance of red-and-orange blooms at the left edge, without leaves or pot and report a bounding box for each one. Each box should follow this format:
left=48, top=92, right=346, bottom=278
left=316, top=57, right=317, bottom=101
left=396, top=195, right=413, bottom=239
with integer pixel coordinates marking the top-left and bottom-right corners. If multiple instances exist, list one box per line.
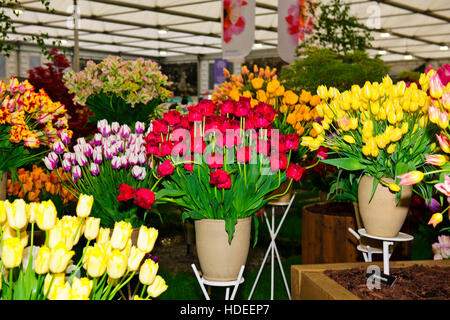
left=0, top=78, right=72, bottom=148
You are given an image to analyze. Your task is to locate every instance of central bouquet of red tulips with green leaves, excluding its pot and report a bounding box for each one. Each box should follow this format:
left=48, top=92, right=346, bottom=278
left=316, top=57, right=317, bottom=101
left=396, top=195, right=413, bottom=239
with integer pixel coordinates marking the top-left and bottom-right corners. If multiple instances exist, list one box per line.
left=145, top=97, right=305, bottom=242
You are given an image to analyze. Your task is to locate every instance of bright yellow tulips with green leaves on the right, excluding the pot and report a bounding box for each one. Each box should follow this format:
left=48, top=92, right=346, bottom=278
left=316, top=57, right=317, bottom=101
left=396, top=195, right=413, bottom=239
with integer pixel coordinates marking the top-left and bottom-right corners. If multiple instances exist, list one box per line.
left=301, top=76, right=435, bottom=200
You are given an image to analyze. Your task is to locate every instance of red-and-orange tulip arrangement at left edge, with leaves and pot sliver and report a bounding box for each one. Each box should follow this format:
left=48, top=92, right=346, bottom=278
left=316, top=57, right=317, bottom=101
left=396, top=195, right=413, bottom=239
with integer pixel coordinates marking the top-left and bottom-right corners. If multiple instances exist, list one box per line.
left=0, top=78, right=72, bottom=200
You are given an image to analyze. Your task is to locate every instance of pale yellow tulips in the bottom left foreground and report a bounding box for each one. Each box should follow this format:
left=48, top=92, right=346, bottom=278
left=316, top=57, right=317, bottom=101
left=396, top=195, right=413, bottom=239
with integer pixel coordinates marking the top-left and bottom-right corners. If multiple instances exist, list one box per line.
left=0, top=195, right=167, bottom=300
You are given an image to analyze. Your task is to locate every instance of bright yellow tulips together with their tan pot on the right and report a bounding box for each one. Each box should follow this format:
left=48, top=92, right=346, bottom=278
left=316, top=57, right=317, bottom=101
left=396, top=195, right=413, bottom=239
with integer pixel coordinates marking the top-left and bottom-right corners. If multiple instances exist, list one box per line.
left=301, top=76, right=434, bottom=237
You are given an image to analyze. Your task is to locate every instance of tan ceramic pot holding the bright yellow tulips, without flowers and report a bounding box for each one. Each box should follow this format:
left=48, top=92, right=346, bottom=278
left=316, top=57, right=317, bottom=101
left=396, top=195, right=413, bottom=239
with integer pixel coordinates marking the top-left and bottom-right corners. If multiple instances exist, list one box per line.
left=358, top=175, right=412, bottom=238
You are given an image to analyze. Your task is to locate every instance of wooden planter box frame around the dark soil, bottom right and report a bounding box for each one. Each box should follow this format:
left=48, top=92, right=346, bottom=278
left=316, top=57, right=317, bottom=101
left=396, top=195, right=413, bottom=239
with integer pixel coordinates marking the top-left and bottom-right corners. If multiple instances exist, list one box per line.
left=291, top=260, right=450, bottom=300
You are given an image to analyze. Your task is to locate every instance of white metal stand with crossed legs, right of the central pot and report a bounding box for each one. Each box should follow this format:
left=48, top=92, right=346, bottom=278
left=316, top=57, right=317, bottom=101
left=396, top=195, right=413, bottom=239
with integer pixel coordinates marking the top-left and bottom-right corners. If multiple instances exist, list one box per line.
left=248, top=193, right=295, bottom=300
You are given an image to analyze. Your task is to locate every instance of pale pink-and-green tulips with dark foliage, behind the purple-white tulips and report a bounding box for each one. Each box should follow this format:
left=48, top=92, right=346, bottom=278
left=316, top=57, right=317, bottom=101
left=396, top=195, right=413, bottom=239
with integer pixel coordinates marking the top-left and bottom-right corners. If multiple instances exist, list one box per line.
left=63, top=56, right=172, bottom=126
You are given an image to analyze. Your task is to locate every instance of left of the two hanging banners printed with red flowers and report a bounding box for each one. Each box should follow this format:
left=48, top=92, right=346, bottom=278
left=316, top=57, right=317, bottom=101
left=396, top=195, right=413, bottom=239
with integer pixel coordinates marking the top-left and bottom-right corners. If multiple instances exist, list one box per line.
left=222, top=0, right=255, bottom=62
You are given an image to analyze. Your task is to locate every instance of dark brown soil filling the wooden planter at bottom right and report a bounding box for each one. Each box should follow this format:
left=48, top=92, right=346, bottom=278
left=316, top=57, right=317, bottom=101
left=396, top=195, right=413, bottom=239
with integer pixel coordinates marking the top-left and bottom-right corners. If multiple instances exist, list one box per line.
left=325, top=264, right=450, bottom=300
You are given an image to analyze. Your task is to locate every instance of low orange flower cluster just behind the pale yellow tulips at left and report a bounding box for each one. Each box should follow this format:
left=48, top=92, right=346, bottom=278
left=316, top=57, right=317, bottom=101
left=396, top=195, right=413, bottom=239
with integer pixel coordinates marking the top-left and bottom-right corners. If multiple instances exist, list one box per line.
left=7, top=165, right=76, bottom=204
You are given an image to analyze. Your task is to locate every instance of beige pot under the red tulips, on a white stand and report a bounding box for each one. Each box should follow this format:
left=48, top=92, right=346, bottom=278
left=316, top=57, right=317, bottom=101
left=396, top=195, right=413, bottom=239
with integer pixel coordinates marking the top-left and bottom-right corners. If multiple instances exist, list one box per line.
left=195, top=217, right=251, bottom=281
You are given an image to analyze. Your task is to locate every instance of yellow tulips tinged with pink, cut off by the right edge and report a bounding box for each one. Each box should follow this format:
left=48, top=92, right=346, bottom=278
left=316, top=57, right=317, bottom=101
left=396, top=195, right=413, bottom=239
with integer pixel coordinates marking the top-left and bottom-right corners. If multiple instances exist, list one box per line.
left=399, top=64, right=450, bottom=231
